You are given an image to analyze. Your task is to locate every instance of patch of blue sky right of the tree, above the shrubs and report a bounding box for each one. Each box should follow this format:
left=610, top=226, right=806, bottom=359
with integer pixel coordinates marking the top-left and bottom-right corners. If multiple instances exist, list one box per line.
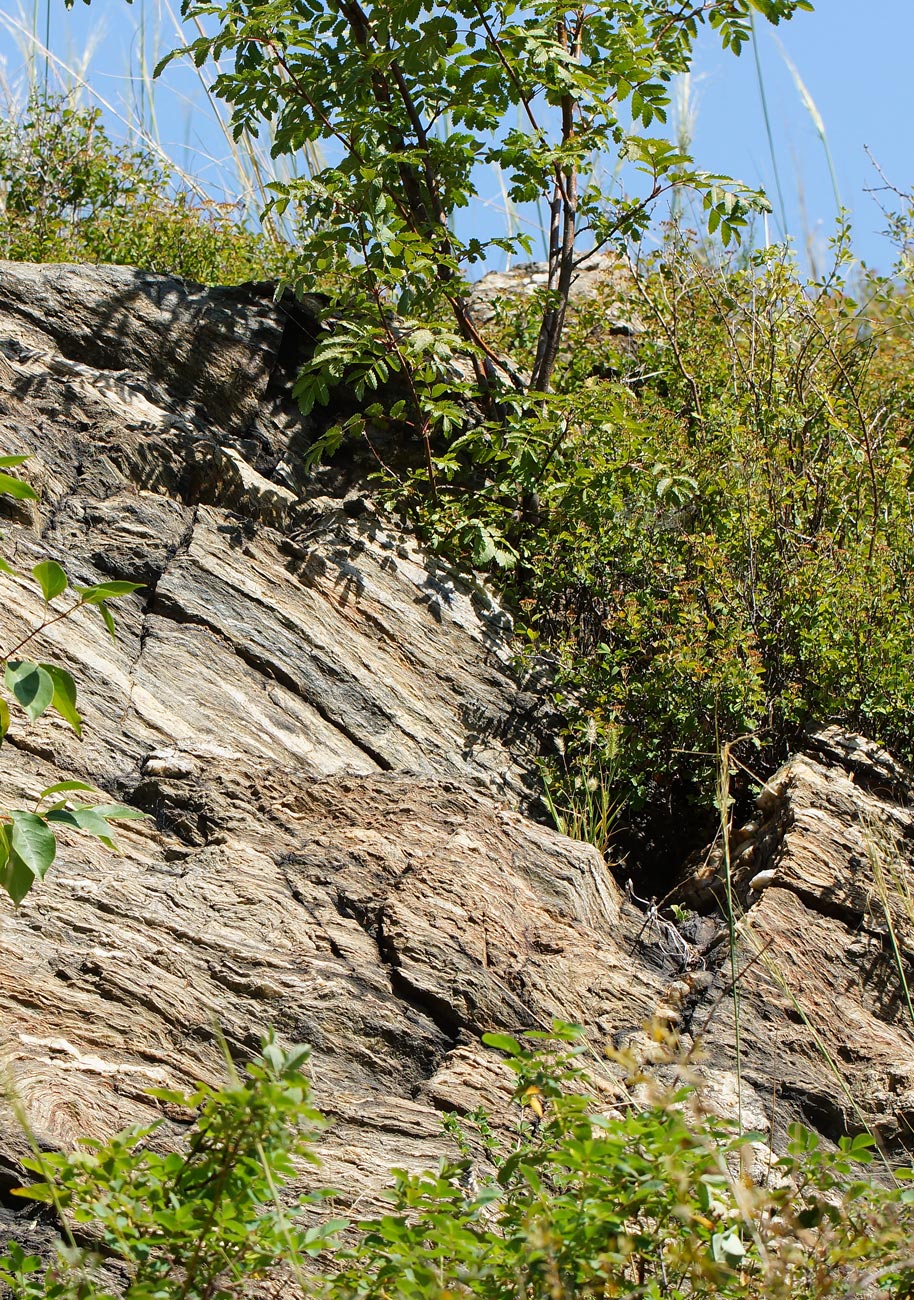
left=693, top=0, right=914, bottom=269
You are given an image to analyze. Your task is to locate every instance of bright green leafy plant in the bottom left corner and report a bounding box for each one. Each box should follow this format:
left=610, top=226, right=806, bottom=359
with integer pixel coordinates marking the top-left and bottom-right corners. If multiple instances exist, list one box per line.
left=0, top=1036, right=343, bottom=1300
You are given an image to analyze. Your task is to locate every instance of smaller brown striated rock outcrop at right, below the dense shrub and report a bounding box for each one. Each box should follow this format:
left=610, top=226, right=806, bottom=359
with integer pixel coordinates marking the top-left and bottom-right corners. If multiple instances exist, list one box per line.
left=671, top=728, right=914, bottom=1152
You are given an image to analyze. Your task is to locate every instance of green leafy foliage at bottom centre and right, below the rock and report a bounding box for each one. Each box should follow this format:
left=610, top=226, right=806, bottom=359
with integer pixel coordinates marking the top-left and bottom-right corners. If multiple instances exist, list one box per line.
left=328, top=1026, right=911, bottom=1300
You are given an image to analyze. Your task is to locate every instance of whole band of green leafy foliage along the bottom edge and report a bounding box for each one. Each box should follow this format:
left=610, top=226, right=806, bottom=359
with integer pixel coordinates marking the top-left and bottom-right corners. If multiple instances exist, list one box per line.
left=0, top=1024, right=914, bottom=1300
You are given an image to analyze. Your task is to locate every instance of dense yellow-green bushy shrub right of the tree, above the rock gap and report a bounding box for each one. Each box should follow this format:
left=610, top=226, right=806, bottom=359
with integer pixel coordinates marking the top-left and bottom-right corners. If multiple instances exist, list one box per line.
left=412, top=229, right=914, bottom=866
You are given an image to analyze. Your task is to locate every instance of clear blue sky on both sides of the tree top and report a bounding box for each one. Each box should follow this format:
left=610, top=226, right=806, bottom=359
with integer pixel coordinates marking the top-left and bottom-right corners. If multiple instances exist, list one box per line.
left=0, top=0, right=914, bottom=270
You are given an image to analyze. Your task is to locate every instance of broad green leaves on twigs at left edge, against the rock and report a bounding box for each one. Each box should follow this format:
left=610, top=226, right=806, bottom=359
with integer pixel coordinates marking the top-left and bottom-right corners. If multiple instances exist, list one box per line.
left=0, top=455, right=146, bottom=905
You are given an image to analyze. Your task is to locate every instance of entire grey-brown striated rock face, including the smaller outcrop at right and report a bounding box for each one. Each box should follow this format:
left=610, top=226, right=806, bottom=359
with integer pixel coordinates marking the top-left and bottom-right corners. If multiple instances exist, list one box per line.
left=0, top=264, right=914, bottom=1236
